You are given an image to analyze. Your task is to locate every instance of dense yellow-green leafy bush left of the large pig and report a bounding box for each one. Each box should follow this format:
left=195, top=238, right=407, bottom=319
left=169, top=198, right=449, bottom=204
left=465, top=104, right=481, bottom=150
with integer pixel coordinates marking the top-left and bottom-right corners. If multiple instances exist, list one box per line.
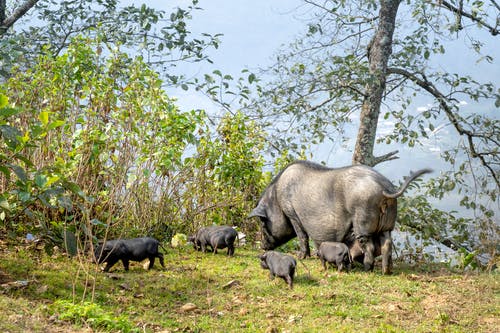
left=0, top=38, right=265, bottom=249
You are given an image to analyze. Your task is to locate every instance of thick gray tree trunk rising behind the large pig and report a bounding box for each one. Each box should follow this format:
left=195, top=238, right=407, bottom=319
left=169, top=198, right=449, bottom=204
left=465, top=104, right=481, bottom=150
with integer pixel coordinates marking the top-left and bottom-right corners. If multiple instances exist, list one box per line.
left=352, top=0, right=400, bottom=166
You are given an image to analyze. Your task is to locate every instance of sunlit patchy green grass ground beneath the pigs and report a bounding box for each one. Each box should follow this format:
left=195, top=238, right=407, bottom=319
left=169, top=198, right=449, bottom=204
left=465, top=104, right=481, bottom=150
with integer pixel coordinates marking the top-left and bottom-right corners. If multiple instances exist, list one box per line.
left=0, top=243, right=500, bottom=332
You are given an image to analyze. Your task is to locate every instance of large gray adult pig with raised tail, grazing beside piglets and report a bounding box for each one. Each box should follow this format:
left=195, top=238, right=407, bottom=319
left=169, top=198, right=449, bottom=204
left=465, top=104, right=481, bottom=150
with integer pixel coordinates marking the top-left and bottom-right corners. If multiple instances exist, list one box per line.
left=249, top=161, right=431, bottom=274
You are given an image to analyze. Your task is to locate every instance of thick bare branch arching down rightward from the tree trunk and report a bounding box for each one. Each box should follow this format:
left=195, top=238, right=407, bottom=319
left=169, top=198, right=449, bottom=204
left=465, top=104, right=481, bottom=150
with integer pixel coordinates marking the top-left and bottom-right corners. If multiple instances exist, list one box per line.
left=387, top=68, right=500, bottom=187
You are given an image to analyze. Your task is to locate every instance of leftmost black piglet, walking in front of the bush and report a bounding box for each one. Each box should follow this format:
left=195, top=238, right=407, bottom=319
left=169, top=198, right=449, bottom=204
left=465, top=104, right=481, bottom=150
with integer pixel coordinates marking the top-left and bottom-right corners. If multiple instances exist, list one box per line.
left=94, top=237, right=165, bottom=272
